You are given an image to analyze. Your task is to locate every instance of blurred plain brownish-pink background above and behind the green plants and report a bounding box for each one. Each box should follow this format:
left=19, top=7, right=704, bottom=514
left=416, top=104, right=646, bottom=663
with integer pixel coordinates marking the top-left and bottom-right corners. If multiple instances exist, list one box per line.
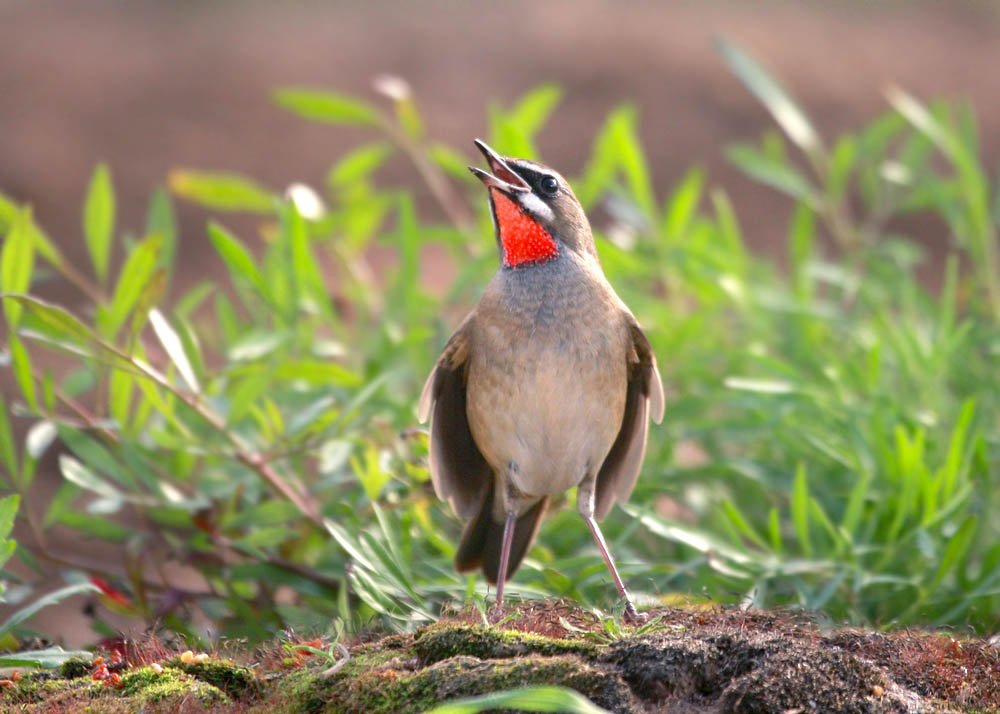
left=0, top=0, right=1000, bottom=645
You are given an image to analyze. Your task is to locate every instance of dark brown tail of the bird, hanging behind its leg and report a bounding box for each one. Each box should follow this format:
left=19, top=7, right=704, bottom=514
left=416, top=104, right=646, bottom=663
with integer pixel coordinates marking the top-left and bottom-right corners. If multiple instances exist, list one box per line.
left=455, top=485, right=549, bottom=585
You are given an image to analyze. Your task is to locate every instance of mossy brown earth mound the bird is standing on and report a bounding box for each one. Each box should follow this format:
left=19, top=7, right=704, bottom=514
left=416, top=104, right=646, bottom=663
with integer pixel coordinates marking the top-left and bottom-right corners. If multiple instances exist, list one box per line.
left=0, top=603, right=1000, bottom=714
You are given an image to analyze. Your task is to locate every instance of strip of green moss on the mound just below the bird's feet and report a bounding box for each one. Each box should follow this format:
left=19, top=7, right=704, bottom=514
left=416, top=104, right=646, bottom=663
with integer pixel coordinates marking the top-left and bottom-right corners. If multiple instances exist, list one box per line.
left=413, top=624, right=598, bottom=665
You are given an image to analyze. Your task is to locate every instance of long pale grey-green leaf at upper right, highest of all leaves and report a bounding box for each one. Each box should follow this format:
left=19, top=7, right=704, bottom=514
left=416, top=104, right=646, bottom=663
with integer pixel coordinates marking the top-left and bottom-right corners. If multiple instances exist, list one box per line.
left=715, top=37, right=823, bottom=160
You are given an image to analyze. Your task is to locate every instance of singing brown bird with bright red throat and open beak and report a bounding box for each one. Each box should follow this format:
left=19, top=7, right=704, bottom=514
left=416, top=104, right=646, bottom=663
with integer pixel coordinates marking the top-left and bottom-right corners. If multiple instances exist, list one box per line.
left=417, top=139, right=664, bottom=621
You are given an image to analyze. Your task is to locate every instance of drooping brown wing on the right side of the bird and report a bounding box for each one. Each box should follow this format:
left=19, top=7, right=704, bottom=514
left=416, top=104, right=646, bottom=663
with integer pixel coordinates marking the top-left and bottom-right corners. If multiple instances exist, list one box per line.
left=594, top=314, right=663, bottom=520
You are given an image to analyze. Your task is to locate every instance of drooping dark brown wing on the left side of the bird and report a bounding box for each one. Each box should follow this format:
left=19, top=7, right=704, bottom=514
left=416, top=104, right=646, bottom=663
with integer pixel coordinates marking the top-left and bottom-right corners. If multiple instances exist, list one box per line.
left=417, top=315, right=492, bottom=520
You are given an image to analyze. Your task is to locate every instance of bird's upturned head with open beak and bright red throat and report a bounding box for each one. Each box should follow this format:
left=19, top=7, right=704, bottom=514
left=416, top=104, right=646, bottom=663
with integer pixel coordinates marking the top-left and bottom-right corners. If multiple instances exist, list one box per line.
left=469, top=139, right=597, bottom=268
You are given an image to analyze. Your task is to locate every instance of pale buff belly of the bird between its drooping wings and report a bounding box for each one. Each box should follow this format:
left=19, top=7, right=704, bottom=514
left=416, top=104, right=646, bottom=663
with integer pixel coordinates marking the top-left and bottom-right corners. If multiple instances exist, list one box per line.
left=467, top=330, right=626, bottom=505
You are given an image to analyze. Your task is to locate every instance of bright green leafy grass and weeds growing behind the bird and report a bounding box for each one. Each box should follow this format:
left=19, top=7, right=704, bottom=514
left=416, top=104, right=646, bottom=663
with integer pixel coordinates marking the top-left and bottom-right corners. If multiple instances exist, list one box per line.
left=0, top=36, right=1000, bottom=656
